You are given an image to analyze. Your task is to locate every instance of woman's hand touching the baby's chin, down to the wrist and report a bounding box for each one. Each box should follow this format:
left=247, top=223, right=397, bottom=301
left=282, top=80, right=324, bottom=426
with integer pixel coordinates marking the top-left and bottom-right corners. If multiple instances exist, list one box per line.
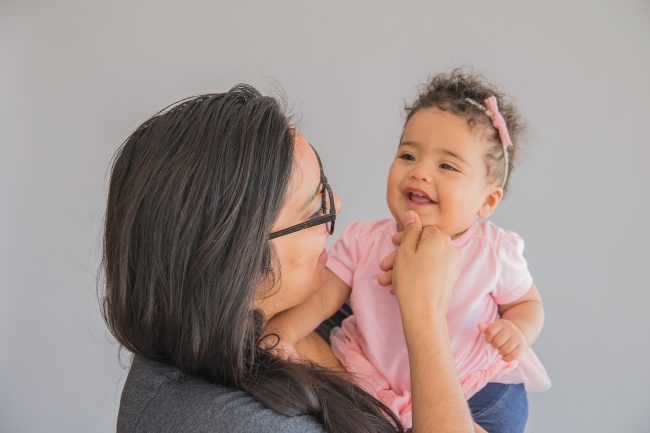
left=382, top=211, right=460, bottom=314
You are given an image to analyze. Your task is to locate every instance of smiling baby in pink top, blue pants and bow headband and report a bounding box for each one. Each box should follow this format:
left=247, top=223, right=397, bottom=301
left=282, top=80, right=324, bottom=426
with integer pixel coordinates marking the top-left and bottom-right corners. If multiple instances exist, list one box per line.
left=267, top=70, right=550, bottom=432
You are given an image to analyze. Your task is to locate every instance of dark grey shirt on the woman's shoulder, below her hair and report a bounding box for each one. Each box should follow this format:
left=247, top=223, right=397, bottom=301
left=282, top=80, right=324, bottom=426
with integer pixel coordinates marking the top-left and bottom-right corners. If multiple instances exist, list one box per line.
left=117, top=356, right=324, bottom=433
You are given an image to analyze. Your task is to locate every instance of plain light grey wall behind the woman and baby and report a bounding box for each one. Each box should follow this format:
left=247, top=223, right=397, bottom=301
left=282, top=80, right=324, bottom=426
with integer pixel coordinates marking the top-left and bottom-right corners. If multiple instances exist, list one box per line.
left=0, top=0, right=650, bottom=433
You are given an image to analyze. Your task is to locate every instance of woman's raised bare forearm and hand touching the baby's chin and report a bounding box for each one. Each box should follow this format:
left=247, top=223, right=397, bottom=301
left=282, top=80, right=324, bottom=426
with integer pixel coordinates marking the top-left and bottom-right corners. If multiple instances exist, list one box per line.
left=384, top=211, right=470, bottom=433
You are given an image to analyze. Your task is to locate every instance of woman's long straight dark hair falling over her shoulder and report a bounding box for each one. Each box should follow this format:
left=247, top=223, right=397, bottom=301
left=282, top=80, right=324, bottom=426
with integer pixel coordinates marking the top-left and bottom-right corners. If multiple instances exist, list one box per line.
left=102, top=85, right=402, bottom=433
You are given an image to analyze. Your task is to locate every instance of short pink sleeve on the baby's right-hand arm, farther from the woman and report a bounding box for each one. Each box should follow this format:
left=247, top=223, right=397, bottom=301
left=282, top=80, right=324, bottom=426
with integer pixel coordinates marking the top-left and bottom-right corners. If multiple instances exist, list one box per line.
left=493, top=231, right=533, bottom=305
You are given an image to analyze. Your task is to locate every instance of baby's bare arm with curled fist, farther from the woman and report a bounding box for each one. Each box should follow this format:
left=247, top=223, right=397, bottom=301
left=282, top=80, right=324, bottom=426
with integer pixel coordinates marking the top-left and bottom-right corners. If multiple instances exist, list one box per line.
left=479, top=286, right=544, bottom=361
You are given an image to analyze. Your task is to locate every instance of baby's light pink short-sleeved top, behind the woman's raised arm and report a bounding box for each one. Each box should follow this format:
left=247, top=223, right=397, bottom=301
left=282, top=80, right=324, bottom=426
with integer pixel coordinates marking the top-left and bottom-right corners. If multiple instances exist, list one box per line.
left=327, top=219, right=551, bottom=428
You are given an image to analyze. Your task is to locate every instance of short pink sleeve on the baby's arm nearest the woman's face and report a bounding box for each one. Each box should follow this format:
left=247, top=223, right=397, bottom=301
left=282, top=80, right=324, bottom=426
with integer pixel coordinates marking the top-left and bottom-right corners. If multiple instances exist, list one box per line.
left=327, top=222, right=367, bottom=287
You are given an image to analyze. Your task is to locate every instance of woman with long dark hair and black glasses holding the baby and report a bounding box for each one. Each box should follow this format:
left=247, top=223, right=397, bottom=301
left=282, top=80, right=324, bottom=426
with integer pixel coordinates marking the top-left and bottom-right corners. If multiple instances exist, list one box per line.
left=103, top=85, right=472, bottom=433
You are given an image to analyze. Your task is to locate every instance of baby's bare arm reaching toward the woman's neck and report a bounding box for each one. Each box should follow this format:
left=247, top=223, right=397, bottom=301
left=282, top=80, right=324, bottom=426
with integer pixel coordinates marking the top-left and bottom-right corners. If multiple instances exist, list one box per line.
left=265, top=268, right=351, bottom=353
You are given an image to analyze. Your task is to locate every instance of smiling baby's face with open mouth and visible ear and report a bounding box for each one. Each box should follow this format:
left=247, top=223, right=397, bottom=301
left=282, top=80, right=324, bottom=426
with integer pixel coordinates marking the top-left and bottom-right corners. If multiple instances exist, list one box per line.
left=387, top=108, right=502, bottom=237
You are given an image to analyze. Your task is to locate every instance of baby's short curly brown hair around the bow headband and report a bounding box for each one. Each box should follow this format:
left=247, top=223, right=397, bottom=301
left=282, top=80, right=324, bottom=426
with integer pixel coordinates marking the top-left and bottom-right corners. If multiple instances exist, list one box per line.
left=404, top=68, right=525, bottom=191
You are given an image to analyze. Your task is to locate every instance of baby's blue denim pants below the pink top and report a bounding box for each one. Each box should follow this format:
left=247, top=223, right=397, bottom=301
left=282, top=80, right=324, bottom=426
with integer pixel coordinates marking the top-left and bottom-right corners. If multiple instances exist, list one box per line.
left=467, top=383, right=528, bottom=433
